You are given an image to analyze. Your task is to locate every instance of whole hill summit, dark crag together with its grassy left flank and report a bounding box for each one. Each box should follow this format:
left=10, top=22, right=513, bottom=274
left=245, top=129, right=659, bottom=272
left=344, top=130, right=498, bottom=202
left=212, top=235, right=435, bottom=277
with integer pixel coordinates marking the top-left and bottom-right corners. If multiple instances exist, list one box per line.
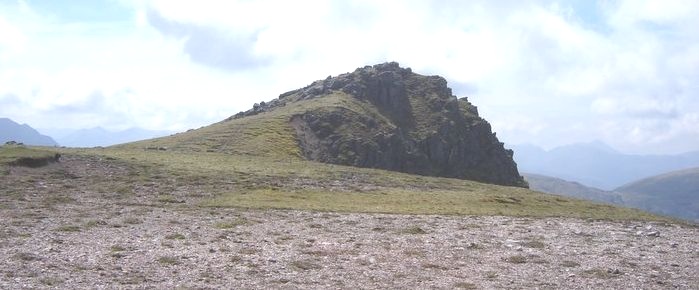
left=138, top=62, right=526, bottom=187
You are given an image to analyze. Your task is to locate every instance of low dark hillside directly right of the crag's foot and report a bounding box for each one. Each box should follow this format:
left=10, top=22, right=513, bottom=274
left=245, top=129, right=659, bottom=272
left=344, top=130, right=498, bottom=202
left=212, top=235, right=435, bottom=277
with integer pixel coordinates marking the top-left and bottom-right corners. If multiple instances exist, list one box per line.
left=522, top=173, right=623, bottom=204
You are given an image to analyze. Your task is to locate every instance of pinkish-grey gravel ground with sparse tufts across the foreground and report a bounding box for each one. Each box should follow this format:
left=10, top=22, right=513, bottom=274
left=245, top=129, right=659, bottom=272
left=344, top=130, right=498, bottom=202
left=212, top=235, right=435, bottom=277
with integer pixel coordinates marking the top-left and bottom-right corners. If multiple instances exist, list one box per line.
left=0, top=158, right=699, bottom=289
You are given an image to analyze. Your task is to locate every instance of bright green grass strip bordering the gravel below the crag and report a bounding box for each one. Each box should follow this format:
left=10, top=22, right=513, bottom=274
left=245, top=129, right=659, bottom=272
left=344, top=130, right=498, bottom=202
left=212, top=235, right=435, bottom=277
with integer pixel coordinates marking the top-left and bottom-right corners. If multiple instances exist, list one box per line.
left=202, top=185, right=651, bottom=219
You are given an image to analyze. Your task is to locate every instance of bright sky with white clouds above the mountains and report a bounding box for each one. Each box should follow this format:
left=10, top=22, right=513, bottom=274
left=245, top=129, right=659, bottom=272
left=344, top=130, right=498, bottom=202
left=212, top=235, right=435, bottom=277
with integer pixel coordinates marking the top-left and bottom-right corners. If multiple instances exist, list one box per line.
left=0, top=0, right=699, bottom=154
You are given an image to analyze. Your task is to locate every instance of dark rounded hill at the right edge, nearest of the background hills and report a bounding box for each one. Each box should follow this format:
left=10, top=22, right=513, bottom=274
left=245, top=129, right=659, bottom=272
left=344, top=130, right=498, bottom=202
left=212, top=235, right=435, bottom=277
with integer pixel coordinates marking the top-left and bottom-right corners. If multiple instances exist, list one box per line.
left=615, top=168, right=699, bottom=222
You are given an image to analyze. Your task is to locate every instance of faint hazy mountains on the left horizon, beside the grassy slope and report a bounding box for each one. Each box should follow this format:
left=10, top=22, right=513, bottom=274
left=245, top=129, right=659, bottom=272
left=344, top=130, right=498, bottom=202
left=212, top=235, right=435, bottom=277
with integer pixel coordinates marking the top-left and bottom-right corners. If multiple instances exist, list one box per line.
left=41, top=127, right=172, bottom=147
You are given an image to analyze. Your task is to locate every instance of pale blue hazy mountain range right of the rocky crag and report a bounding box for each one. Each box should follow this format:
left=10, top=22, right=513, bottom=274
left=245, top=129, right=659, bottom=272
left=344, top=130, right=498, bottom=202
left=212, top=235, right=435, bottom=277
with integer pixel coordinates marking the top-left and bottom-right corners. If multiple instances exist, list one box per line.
left=511, top=142, right=699, bottom=190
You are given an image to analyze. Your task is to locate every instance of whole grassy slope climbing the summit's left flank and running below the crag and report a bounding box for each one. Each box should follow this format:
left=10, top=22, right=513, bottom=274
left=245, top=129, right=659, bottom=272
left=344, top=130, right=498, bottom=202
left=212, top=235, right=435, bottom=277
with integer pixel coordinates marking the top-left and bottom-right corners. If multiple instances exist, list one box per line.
left=0, top=93, right=676, bottom=219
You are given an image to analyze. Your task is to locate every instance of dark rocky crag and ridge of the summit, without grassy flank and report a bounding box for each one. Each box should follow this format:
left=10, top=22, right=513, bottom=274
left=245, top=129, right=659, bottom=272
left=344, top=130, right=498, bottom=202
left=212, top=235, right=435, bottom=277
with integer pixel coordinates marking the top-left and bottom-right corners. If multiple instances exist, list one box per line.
left=232, top=62, right=527, bottom=187
